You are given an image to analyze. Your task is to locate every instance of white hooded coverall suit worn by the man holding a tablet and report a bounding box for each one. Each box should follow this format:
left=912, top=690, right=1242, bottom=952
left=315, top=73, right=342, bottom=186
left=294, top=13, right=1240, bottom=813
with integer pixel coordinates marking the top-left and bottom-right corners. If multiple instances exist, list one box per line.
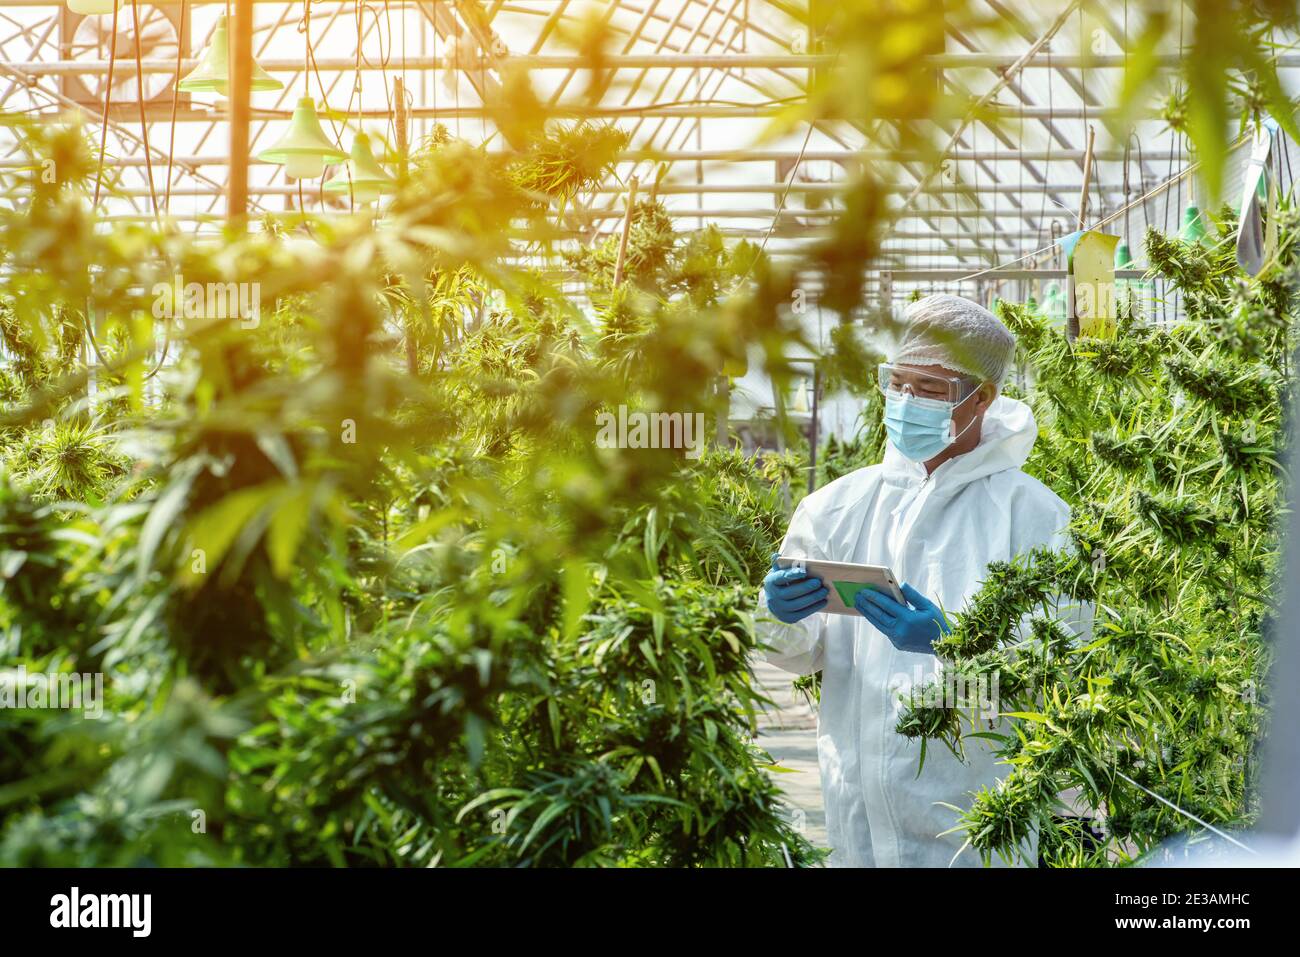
left=759, top=397, right=1086, bottom=867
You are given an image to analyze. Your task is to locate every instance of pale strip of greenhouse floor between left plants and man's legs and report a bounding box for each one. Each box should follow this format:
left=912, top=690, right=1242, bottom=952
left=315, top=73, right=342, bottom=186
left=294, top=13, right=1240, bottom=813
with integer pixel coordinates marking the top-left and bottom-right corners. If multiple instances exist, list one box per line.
left=754, top=661, right=827, bottom=848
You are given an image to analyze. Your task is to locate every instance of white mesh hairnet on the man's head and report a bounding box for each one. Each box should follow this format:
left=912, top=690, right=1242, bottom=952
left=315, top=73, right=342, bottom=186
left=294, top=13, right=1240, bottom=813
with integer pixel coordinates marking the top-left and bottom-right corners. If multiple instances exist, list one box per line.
left=893, top=294, right=1015, bottom=386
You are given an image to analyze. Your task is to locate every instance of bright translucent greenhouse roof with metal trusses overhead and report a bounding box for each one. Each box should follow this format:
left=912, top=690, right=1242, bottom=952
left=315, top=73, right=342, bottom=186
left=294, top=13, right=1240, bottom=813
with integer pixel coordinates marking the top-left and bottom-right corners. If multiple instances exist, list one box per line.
left=0, top=0, right=1300, bottom=300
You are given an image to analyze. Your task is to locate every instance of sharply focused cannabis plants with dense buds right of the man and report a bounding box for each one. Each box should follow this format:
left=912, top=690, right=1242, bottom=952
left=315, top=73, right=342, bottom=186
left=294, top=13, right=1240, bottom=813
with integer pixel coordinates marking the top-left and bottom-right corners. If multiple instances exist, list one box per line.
left=898, top=208, right=1300, bottom=866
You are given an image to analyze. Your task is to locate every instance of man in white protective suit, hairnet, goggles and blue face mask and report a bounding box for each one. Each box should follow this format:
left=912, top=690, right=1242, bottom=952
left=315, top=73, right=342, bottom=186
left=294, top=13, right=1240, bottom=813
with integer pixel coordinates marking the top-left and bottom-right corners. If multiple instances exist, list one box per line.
left=759, top=295, right=1091, bottom=867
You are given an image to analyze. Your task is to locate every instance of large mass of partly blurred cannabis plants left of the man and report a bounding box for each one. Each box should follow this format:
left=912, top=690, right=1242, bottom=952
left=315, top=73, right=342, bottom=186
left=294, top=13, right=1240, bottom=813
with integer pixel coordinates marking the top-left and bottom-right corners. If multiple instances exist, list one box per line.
left=0, top=111, right=819, bottom=866
